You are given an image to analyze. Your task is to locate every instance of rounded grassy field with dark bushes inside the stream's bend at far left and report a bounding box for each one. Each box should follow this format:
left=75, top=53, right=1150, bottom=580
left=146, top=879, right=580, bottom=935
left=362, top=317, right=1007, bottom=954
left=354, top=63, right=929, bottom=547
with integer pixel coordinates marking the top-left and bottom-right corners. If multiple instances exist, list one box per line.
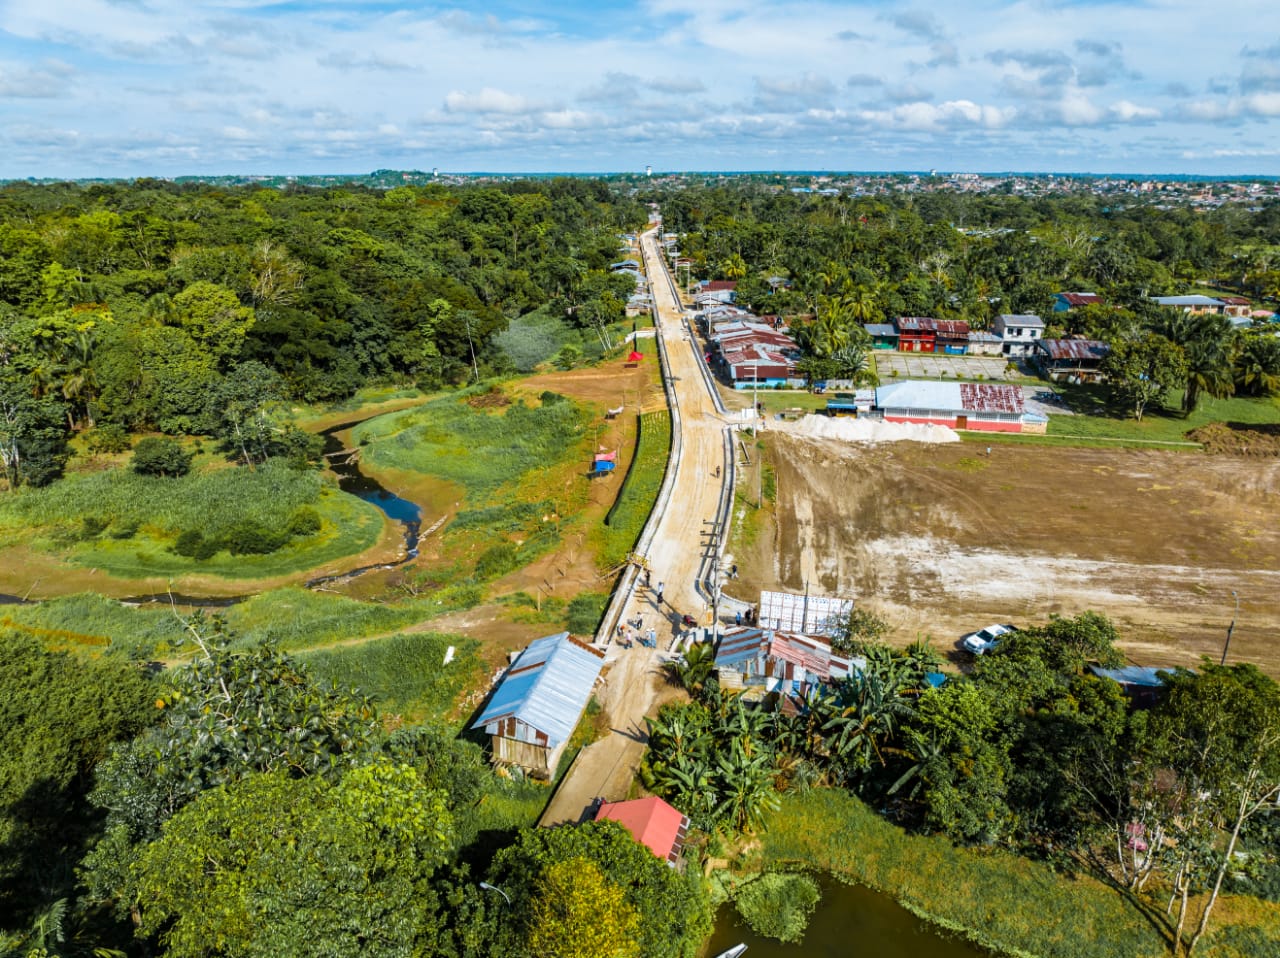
left=0, top=461, right=384, bottom=579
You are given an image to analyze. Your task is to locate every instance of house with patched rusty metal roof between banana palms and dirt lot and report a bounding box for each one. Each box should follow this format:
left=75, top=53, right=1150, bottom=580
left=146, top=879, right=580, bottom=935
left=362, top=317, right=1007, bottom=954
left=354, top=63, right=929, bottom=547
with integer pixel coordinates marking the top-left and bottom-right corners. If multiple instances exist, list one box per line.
left=716, top=626, right=865, bottom=698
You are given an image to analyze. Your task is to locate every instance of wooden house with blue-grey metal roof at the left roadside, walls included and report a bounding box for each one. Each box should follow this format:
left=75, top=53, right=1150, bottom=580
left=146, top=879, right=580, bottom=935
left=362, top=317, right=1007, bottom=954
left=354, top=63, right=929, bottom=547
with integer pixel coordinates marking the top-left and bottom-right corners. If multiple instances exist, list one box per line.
left=471, top=631, right=604, bottom=779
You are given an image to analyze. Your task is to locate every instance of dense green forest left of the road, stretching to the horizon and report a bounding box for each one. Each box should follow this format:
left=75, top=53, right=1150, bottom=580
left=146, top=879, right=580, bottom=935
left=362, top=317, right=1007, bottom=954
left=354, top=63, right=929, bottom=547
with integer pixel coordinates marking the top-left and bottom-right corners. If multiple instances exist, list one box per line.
left=0, top=179, right=645, bottom=487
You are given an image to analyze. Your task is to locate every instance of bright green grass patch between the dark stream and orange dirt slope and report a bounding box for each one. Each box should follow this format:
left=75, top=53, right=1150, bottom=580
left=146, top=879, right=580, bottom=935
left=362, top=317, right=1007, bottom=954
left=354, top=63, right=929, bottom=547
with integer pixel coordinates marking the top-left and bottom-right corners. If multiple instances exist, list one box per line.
left=353, top=389, right=591, bottom=503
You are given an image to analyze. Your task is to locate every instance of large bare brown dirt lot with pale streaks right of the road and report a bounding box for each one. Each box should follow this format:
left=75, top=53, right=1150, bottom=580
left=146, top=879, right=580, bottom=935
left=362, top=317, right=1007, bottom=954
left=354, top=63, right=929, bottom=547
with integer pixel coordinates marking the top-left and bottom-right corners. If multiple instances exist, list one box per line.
left=735, top=434, right=1280, bottom=675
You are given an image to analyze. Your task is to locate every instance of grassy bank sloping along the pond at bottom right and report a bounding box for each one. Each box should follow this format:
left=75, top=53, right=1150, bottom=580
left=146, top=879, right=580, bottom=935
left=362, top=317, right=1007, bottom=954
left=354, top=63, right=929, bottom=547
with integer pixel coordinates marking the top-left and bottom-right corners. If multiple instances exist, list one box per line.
left=754, top=789, right=1280, bottom=958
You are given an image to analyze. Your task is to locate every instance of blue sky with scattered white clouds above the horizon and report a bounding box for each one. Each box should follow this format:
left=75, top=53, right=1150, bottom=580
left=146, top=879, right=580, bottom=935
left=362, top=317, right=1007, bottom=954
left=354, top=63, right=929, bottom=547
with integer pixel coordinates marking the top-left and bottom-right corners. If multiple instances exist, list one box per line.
left=0, top=0, right=1280, bottom=178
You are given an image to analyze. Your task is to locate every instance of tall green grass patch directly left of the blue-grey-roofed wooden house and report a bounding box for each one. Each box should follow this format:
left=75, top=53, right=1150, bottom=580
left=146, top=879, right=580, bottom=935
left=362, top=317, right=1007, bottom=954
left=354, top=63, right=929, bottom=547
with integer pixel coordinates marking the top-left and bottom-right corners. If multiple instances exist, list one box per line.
left=300, top=633, right=481, bottom=722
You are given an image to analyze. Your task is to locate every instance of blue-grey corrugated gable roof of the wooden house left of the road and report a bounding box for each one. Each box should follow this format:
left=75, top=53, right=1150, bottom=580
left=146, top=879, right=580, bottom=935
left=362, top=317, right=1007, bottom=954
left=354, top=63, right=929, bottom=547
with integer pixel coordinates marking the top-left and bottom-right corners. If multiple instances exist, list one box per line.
left=471, top=631, right=604, bottom=748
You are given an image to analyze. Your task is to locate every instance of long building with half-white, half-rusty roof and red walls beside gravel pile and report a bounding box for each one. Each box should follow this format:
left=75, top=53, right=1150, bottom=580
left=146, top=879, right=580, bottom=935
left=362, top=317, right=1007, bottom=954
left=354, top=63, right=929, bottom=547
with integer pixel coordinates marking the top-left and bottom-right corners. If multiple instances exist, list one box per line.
left=876, top=379, right=1027, bottom=433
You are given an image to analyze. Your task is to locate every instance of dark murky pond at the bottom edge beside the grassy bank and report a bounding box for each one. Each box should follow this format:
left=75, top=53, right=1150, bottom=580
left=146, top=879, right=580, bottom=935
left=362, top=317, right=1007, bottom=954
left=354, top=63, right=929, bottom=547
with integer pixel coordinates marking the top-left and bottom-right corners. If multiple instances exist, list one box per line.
left=707, top=877, right=988, bottom=958
